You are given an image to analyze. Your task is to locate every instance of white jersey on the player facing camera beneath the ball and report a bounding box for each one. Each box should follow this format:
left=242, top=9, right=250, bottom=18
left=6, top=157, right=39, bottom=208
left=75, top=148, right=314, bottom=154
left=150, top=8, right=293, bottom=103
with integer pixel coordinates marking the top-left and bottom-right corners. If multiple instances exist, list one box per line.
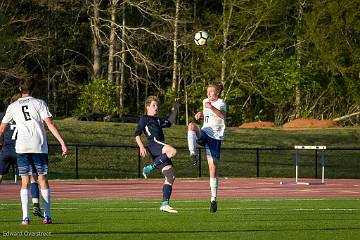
left=201, top=98, right=226, bottom=140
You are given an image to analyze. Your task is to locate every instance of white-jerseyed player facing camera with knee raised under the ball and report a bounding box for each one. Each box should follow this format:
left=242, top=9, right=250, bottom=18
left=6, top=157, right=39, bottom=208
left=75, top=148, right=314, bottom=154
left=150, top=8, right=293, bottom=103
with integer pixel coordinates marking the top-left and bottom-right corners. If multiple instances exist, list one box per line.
left=188, top=83, right=226, bottom=213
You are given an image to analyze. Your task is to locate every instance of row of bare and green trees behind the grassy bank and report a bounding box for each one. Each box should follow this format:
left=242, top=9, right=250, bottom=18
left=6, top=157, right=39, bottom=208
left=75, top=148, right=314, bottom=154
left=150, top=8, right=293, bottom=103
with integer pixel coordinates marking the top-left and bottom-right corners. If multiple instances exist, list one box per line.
left=0, top=0, right=360, bottom=125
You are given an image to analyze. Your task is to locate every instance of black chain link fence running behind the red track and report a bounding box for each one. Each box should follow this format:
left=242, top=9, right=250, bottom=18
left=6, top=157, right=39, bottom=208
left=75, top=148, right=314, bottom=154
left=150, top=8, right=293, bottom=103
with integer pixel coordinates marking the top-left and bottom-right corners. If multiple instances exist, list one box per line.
left=39, top=145, right=360, bottom=179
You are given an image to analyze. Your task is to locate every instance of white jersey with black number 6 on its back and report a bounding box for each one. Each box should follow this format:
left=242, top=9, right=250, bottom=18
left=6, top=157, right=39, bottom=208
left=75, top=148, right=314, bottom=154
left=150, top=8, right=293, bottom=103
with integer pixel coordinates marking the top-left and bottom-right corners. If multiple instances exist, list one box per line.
left=2, top=97, right=52, bottom=153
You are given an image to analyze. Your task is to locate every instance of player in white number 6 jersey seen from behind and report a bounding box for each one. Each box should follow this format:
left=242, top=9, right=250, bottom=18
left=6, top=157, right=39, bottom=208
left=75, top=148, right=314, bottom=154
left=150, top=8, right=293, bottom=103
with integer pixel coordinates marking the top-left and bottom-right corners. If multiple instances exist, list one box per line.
left=0, top=79, right=68, bottom=225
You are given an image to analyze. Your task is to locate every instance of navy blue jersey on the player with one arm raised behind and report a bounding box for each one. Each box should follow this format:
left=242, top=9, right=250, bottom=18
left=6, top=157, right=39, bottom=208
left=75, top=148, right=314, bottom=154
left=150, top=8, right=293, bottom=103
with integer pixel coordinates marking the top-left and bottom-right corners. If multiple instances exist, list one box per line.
left=135, top=115, right=171, bottom=142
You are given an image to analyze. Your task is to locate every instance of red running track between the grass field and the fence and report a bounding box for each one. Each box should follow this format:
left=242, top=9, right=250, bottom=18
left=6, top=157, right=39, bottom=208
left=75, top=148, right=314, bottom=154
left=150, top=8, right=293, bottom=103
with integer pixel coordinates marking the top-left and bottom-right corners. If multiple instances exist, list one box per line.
left=0, top=178, right=360, bottom=200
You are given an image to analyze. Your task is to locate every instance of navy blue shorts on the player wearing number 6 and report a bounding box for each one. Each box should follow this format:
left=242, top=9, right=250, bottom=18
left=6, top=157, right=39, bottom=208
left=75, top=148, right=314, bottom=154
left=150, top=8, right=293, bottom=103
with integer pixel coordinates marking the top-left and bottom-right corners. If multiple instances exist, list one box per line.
left=17, top=153, right=48, bottom=176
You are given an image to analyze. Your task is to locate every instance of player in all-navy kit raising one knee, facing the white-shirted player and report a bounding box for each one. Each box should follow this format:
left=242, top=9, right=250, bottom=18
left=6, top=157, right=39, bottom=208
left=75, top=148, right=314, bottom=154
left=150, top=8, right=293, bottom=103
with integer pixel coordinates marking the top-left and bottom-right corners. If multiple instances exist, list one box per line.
left=135, top=96, right=179, bottom=213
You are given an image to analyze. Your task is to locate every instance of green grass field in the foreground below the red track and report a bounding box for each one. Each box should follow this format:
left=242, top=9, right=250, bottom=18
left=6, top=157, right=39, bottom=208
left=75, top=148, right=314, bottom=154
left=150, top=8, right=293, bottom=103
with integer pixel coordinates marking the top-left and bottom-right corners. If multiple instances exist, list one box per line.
left=0, top=199, right=360, bottom=240
